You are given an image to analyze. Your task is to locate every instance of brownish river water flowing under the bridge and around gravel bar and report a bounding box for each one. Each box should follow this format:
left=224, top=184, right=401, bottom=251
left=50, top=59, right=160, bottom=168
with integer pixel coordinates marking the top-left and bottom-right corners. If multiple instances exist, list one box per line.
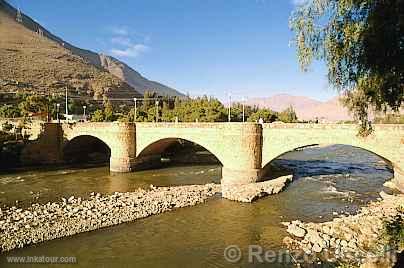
left=0, top=145, right=392, bottom=267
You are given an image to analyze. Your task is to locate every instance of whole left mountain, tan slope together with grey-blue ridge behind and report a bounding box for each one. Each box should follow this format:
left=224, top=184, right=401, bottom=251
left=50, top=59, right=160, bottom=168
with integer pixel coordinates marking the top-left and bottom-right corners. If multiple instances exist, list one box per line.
left=0, top=0, right=182, bottom=98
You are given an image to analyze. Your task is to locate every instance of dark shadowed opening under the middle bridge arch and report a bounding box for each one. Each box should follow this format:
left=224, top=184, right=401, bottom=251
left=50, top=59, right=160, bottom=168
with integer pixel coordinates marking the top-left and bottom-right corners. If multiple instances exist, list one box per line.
left=136, top=138, right=222, bottom=169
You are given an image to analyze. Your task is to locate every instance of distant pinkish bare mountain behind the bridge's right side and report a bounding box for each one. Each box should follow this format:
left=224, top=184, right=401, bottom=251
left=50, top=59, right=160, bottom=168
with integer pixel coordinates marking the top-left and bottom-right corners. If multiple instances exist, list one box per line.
left=247, top=94, right=352, bottom=122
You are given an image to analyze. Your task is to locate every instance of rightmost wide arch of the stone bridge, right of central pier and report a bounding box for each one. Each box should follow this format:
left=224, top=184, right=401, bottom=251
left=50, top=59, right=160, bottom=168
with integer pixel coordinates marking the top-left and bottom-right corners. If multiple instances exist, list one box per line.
left=262, top=124, right=404, bottom=189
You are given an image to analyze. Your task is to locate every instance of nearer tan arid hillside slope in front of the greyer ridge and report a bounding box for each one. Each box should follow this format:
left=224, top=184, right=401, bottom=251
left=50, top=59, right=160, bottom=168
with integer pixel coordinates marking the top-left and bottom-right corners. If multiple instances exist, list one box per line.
left=0, top=0, right=139, bottom=98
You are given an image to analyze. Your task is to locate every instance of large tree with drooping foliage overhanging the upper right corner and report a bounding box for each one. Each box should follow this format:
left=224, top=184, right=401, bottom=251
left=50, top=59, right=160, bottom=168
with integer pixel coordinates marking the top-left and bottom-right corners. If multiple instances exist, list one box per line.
left=290, top=0, right=404, bottom=133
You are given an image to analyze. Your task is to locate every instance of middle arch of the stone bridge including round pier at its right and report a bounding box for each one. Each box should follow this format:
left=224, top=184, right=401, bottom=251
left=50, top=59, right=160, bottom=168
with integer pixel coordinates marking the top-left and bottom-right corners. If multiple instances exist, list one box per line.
left=136, top=123, right=262, bottom=184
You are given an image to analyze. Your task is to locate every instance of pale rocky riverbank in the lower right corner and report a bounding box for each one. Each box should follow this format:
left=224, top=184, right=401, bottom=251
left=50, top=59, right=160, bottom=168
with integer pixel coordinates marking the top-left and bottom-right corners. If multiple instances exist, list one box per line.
left=283, top=187, right=404, bottom=267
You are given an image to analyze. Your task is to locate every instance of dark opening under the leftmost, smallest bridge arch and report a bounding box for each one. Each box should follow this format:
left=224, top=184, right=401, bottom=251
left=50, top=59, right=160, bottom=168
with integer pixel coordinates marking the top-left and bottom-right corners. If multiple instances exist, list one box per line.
left=63, top=135, right=111, bottom=165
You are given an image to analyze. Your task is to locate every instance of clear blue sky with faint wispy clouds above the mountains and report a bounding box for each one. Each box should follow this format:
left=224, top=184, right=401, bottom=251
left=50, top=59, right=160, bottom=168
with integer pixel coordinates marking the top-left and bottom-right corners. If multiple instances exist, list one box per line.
left=9, top=0, right=336, bottom=100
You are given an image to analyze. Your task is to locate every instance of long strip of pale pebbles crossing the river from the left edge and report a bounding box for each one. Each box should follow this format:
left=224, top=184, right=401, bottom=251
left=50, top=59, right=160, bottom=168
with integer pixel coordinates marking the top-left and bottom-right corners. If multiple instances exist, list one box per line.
left=0, top=184, right=220, bottom=252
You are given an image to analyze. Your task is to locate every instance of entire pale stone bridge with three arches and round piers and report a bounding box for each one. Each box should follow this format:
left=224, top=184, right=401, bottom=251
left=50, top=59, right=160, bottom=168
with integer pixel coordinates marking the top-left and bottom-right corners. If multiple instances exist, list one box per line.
left=23, top=122, right=404, bottom=190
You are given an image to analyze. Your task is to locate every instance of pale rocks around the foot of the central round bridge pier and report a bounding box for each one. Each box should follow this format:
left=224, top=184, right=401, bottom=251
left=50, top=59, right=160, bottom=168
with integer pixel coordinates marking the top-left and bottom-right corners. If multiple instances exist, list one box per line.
left=222, top=175, right=293, bottom=203
